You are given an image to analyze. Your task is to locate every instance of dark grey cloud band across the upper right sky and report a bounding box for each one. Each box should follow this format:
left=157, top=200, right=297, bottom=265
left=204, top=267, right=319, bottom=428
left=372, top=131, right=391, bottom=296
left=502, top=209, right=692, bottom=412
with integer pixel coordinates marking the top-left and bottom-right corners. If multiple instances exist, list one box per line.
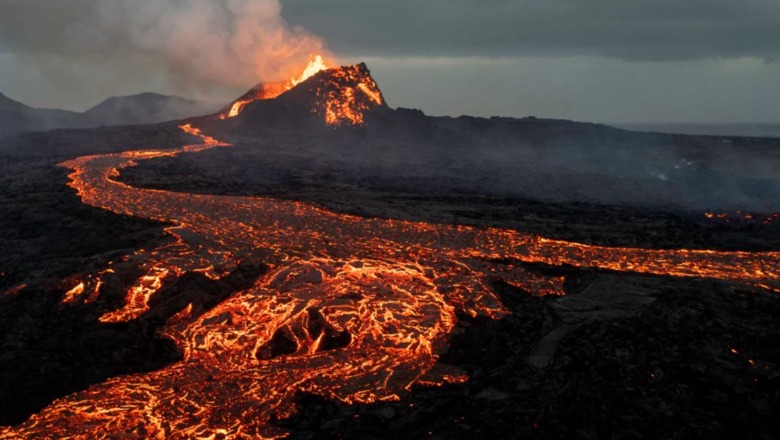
left=283, top=0, right=780, bottom=61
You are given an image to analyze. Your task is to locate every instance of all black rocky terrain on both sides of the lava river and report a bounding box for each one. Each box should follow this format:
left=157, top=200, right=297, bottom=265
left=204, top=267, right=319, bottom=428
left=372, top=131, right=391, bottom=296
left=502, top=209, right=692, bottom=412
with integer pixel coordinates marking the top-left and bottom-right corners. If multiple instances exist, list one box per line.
left=0, top=65, right=780, bottom=439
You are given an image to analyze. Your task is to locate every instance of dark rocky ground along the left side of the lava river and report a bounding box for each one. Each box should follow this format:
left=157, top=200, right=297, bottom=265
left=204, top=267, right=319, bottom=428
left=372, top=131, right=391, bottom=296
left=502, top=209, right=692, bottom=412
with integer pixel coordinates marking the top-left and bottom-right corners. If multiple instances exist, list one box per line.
left=0, top=125, right=198, bottom=424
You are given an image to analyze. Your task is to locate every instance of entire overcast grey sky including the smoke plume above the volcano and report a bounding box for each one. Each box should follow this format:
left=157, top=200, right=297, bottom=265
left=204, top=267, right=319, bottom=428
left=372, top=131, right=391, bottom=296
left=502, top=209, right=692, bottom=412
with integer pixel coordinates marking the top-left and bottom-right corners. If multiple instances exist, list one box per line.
left=0, top=0, right=780, bottom=123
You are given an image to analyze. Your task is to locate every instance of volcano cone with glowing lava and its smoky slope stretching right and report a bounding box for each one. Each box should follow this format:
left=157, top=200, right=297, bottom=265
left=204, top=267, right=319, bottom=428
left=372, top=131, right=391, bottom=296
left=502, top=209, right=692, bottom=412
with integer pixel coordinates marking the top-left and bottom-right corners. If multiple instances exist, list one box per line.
left=140, top=65, right=780, bottom=217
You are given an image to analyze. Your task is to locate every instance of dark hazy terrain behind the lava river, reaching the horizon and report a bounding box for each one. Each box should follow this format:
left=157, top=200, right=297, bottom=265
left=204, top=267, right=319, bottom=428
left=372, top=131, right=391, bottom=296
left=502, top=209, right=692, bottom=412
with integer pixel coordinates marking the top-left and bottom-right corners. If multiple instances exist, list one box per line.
left=119, top=90, right=780, bottom=250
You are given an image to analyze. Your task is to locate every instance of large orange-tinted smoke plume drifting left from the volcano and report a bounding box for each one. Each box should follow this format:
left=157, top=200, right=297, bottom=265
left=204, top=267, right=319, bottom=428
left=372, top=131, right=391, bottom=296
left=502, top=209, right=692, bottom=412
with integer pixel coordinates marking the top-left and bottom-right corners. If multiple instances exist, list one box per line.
left=0, top=0, right=327, bottom=103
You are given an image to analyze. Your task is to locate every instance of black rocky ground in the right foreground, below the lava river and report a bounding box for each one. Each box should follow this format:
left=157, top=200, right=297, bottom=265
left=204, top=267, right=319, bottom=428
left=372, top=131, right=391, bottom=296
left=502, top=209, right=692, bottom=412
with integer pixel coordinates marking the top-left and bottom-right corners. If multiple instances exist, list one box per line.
left=282, top=273, right=780, bottom=439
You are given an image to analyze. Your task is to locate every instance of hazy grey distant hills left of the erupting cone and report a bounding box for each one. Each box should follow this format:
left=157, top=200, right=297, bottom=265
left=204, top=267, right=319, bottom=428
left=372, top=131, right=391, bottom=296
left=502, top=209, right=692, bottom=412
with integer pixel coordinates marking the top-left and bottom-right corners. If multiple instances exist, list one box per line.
left=0, top=93, right=221, bottom=136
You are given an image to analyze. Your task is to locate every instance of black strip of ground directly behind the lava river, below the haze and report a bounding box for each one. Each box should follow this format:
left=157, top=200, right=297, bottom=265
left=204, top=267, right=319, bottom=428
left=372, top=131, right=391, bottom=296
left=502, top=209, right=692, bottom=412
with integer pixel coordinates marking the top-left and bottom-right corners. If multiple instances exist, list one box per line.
left=120, top=137, right=780, bottom=251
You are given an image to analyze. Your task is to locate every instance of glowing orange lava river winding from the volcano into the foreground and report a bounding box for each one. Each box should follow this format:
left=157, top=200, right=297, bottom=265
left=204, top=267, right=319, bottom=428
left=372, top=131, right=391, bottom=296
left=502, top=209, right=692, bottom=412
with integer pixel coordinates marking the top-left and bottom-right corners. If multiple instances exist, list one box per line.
left=0, top=126, right=780, bottom=439
